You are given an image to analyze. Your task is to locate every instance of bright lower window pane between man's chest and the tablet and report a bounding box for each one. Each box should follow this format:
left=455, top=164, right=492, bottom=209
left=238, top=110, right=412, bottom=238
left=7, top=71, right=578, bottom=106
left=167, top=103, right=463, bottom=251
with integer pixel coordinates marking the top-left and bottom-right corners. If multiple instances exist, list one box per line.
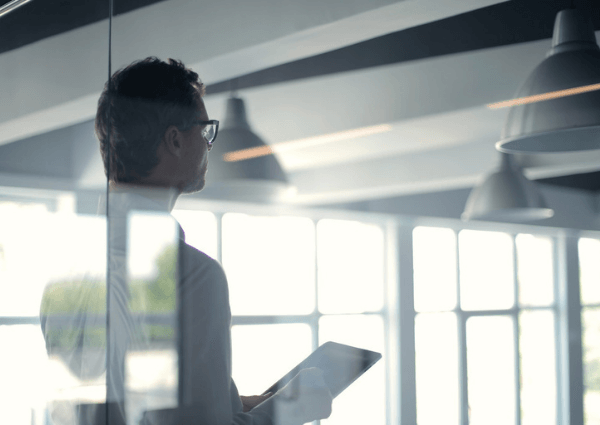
left=231, top=323, right=312, bottom=394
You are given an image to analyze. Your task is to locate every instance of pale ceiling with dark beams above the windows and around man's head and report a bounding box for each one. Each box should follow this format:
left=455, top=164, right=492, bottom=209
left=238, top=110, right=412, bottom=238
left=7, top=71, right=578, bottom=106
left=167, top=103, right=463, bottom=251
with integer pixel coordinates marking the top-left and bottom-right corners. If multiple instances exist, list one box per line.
left=0, top=0, right=600, bottom=204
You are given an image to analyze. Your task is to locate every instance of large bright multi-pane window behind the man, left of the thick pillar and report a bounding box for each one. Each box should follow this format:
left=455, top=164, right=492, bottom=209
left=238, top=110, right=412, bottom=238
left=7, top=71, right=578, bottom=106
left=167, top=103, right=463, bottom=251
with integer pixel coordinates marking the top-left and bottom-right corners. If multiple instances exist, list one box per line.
left=0, top=196, right=389, bottom=425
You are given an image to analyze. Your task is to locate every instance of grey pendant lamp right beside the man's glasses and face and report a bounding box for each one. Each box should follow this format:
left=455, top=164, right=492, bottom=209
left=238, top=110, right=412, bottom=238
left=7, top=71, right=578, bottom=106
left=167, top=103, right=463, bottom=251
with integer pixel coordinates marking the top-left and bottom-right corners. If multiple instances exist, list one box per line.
left=201, top=96, right=289, bottom=202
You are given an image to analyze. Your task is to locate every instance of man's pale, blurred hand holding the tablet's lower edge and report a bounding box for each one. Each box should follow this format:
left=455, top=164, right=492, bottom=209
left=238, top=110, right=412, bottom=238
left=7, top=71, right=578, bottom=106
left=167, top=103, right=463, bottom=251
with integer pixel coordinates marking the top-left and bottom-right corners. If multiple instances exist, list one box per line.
left=273, top=367, right=333, bottom=425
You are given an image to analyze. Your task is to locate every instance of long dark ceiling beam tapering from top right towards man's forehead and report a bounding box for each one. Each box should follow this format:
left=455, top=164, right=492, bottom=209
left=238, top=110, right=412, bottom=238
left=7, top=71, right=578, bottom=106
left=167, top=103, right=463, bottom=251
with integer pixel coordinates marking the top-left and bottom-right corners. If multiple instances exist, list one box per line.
left=206, top=0, right=600, bottom=95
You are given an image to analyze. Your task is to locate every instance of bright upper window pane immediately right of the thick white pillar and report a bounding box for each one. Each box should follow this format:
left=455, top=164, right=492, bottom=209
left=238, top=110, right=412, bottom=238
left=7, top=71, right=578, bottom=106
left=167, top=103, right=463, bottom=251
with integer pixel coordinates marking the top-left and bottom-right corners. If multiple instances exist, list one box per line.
left=413, top=227, right=456, bottom=311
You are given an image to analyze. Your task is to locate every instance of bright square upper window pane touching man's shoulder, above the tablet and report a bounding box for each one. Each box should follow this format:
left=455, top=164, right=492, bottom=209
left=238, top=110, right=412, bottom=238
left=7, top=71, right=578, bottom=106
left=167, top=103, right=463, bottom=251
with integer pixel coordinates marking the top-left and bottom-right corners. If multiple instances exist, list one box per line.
left=223, top=214, right=315, bottom=315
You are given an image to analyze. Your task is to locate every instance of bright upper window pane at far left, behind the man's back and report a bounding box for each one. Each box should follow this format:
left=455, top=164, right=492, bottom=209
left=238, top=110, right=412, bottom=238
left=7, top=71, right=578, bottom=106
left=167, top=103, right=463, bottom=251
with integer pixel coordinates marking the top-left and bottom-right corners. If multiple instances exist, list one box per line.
left=0, top=202, right=99, bottom=317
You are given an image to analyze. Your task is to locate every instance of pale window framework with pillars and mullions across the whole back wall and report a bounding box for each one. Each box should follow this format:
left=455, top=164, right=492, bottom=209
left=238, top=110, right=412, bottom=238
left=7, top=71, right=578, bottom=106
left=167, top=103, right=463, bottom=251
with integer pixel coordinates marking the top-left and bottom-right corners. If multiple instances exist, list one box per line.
left=0, top=190, right=600, bottom=425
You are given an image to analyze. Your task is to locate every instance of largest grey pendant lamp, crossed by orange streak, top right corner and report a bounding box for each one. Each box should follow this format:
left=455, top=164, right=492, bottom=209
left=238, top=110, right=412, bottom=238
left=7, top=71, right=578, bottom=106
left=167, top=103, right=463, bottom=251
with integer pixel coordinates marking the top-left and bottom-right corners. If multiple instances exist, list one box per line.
left=496, top=9, right=600, bottom=153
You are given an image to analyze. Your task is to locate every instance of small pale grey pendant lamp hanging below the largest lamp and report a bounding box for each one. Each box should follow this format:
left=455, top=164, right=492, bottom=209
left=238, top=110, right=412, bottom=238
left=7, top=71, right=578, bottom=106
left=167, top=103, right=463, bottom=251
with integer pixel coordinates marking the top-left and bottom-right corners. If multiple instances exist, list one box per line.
left=462, top=154, right=554, bottom=221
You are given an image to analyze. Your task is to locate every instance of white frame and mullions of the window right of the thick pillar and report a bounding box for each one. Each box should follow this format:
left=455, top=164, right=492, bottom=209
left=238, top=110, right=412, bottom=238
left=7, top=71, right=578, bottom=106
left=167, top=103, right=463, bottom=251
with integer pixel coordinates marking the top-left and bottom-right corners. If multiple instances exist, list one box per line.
left=406, top=217, right=588, bottom=425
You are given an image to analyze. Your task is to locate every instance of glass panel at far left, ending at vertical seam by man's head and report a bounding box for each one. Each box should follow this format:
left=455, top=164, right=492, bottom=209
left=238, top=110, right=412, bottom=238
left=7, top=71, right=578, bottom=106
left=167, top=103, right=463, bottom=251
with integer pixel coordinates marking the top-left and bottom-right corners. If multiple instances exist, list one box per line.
left=0, top=1, right=109, bottom=425
